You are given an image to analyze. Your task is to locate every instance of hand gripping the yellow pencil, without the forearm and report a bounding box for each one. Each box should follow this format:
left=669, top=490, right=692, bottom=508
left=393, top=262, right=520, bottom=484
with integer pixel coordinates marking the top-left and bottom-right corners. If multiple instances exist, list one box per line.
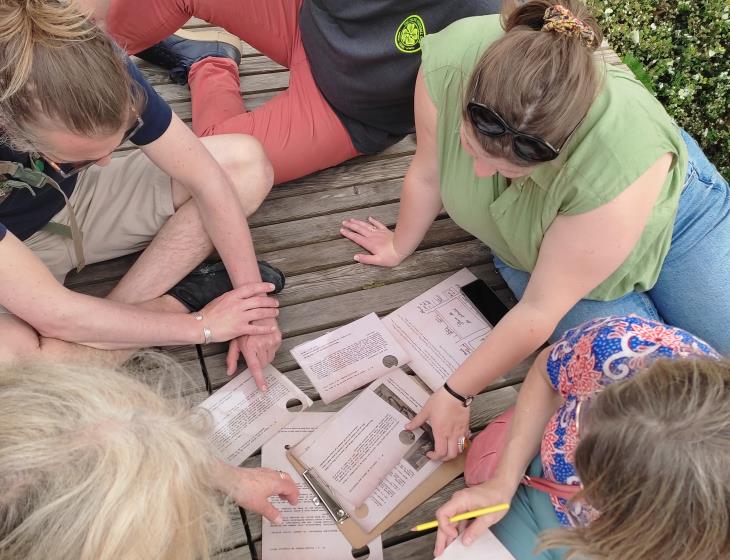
left=433, top=478, right=517, bottom=556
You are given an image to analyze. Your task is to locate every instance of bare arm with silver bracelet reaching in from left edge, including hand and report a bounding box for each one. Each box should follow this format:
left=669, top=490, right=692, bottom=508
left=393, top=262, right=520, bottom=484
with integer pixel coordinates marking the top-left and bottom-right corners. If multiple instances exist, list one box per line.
left=0, top=232, right=277, bottom=349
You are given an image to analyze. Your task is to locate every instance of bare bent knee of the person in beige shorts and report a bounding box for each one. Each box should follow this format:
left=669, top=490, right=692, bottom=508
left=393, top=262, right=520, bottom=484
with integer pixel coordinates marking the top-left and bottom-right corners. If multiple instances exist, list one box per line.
left=220, top=134, right=274, bottom=215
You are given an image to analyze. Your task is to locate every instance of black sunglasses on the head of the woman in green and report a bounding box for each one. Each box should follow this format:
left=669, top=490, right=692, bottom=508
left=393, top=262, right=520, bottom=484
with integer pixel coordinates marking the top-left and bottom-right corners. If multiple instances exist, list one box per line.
left=466, top=100, right=564, bottom=163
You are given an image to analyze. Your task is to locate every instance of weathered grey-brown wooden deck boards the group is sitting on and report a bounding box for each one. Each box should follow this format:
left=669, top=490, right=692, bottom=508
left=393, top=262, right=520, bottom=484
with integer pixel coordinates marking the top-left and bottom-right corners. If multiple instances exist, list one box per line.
left=66, top=20, right=617, bottom=560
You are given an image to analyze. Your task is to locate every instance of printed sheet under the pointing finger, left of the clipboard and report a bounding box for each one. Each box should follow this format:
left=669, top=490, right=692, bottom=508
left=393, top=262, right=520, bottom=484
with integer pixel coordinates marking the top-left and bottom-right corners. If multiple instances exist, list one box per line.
left=199, top=365, right=312, bottom=465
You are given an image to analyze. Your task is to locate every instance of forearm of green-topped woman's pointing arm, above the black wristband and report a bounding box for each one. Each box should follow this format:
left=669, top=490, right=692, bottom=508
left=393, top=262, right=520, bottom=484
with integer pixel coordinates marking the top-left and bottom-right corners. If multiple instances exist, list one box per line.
left=449, top=300, right=560, bottom=395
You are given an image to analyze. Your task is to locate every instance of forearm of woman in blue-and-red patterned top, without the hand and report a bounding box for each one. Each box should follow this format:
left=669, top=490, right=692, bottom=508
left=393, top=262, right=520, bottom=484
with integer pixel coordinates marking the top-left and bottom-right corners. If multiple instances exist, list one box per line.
left=494, top=350, right=561, bottom=488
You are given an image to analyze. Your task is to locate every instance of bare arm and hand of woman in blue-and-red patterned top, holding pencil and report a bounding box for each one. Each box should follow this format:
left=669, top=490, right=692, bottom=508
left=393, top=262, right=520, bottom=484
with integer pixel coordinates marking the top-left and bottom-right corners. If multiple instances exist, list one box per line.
left=434, top=348, right=562, bottom=556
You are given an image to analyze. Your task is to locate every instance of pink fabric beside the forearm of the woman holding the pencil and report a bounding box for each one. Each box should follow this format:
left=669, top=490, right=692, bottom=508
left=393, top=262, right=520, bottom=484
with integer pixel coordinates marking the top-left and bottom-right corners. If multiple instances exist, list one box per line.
left=464, top=407, right=515, bottom=486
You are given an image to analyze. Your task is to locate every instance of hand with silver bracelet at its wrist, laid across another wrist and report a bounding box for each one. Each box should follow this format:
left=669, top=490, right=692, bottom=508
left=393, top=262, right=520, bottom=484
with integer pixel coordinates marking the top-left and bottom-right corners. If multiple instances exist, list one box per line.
left=200, top=282, right=279, bottom=342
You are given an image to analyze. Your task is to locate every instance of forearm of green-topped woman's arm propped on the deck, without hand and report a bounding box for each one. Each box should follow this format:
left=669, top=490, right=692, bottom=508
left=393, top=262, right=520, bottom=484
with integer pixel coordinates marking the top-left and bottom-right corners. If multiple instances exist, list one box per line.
left=393, top=165, right=442, bottom=258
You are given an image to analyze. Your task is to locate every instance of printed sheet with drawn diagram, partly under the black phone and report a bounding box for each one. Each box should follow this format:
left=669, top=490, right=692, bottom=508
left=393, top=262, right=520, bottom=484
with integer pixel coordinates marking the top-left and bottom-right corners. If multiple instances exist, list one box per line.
left=382, top=268, right=492, bottom=391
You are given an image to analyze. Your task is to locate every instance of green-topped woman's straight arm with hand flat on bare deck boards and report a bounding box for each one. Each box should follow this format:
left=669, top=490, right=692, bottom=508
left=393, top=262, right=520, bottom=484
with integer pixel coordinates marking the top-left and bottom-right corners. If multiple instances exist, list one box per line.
left=340, top=71, right=442, bottom=266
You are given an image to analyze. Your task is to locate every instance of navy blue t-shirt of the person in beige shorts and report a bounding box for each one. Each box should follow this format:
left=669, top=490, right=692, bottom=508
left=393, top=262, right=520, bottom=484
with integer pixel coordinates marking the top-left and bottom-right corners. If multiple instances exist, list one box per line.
left=0, top=59, right=172, bottom=240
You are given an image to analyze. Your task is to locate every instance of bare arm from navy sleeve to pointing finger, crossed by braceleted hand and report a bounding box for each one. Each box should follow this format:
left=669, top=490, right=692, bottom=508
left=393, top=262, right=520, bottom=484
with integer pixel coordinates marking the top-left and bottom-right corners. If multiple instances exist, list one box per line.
left=142, top=115, right=281, bottom=382
